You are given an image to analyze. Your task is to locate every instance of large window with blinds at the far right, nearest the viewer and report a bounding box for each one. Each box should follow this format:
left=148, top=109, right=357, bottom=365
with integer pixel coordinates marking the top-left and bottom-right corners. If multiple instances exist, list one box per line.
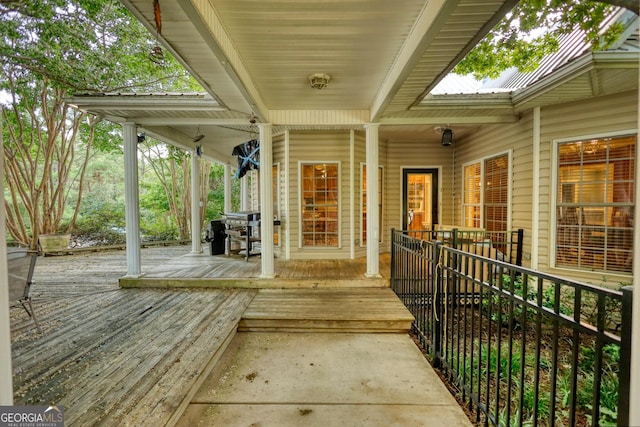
left=555, top=136, right=636, bottom=273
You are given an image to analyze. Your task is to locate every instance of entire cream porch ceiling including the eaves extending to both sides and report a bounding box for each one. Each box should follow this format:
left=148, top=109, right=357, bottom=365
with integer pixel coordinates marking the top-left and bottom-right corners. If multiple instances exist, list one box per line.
left=70, top=0, right=638, bottom=164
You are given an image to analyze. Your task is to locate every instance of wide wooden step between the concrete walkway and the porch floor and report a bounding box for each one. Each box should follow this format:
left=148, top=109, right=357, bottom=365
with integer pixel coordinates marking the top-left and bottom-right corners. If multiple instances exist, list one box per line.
left=238, top=288, right=414, bottom=333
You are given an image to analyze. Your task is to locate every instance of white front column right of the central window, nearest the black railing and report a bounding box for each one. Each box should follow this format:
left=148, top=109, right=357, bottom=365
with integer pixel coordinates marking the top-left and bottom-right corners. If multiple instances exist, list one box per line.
left=365, top=123, right=381, bottom=278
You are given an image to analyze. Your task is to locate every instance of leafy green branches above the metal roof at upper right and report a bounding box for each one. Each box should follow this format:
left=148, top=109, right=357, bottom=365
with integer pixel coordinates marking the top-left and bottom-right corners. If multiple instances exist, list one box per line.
left=454, top=0, right=639, bottom=79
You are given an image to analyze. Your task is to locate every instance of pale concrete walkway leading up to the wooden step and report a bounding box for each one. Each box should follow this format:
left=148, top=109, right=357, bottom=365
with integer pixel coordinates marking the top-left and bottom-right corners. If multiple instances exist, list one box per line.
left=178, top=332, right=471, bottom=427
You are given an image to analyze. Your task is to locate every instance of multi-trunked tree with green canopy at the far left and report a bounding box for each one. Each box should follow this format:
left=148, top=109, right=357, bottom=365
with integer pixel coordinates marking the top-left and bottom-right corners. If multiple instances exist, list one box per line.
left=0, top=0, right=196, bottom=248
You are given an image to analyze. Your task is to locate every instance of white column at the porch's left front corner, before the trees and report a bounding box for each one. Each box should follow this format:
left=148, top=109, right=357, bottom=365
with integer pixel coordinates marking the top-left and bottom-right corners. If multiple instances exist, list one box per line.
left=122, top=122, right=142, bottom=276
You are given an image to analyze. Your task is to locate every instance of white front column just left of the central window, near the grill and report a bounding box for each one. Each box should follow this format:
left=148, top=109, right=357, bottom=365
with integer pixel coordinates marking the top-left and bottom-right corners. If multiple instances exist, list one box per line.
left=260, top=123, right=275, bottom=278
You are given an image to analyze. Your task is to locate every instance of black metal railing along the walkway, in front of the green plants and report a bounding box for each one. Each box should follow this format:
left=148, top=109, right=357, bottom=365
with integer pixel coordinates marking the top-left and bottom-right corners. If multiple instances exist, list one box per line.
left=391, top=230, right=631, bottom=426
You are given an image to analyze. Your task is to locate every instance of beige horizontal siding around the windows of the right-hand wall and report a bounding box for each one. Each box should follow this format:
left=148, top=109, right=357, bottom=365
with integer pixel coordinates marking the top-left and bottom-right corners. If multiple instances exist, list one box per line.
left=456, top=91, right=638, bottom=285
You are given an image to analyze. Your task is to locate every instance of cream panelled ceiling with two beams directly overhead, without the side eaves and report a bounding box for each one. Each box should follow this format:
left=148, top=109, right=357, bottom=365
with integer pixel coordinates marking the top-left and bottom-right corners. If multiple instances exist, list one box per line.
left=123, top=0, right=516, bottom=121
